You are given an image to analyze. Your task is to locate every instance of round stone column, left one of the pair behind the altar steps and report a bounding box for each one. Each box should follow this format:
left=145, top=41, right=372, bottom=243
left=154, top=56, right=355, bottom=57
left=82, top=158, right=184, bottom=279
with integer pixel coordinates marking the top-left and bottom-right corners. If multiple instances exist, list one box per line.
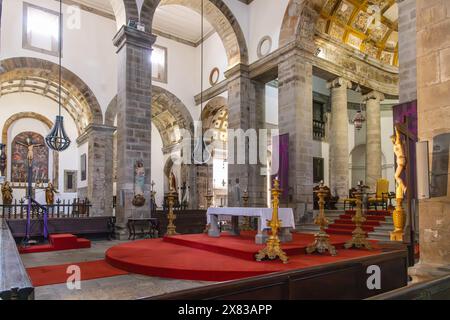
left=328, top=78, right=352, bottom=199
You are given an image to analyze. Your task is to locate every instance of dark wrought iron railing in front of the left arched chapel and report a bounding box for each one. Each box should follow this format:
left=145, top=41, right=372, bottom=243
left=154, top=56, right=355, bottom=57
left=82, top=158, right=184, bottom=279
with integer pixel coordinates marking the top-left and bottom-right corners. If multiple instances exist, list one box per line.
left=0, top=199, right=92, bottom=219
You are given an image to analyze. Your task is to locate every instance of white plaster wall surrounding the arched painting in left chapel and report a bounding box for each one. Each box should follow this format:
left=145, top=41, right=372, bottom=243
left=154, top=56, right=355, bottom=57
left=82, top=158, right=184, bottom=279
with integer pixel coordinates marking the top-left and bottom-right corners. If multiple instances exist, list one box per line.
left=0, top=93, right=79, bottom=201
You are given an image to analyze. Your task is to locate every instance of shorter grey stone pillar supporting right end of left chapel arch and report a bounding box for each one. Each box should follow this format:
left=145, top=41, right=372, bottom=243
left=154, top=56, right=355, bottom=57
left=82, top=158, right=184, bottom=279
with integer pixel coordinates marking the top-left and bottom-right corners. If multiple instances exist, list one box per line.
left=77, top=124, right=116, bottom=216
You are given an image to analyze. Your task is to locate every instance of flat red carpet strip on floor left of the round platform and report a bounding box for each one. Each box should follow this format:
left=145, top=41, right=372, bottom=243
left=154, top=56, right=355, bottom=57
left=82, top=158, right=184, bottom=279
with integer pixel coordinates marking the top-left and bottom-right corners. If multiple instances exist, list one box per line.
left=27, top=260, right=128, bottom=287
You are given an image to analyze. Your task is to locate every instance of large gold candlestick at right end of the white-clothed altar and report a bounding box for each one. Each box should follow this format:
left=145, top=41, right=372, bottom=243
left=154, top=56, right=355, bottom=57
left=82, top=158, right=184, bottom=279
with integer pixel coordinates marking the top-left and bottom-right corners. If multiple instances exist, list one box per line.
left=255, top=179, right=289, bottom=263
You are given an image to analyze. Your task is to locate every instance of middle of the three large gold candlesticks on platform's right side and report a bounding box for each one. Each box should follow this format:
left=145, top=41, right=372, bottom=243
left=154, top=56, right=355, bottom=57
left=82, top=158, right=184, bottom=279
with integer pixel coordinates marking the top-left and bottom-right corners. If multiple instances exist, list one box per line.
left=306, top=181, right=337, bottom=256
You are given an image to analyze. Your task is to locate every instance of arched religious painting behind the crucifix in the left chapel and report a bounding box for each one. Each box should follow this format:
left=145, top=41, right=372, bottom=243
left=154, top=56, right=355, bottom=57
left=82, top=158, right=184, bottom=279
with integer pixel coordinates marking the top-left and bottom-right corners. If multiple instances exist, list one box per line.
left=11, top=131, right=49, bottom=183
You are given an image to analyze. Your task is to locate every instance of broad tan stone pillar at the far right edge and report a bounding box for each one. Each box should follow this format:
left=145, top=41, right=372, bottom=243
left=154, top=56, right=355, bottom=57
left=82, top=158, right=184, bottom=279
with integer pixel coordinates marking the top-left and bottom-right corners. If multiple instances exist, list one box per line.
left=410, top=0, right=450, bottom=281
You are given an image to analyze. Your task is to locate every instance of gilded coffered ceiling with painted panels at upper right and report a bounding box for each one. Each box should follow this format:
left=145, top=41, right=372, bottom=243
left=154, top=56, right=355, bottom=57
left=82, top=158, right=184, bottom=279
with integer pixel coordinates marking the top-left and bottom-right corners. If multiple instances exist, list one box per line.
left=316, top=0, right=398, bottom=66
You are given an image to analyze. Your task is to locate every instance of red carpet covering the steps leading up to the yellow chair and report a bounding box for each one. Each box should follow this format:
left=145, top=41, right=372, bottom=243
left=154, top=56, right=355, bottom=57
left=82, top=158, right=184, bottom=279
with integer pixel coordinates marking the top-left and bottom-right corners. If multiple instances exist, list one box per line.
left=327, top=210, right=390, bottom=236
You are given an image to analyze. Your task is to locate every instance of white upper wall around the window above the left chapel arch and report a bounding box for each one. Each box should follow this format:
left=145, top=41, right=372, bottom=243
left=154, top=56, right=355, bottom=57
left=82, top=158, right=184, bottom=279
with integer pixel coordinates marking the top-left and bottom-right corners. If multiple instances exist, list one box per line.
left=0, top=0, right=117, bottom=115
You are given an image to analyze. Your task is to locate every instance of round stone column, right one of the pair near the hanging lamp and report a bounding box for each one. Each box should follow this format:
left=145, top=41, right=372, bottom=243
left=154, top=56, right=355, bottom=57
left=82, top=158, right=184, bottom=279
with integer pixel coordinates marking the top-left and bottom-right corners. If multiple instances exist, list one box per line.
left=364, top=91, right=384, bottom=192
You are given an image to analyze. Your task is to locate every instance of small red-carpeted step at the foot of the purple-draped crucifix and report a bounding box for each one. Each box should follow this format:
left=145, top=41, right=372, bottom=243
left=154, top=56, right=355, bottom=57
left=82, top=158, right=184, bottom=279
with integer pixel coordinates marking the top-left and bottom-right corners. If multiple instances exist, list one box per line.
left=19, top=234, right=91, bottom=254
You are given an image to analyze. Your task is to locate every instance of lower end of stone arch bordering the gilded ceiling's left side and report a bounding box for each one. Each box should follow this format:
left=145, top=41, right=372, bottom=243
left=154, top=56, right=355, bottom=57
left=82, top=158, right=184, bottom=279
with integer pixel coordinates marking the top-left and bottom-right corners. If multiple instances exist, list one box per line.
left=279, top=0, right=326, bottom=48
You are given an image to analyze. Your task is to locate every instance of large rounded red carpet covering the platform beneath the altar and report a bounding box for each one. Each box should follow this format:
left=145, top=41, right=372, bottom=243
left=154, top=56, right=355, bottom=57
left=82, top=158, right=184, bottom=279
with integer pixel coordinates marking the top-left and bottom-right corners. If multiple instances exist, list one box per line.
left=105, top=233, right=380, bottom=281
